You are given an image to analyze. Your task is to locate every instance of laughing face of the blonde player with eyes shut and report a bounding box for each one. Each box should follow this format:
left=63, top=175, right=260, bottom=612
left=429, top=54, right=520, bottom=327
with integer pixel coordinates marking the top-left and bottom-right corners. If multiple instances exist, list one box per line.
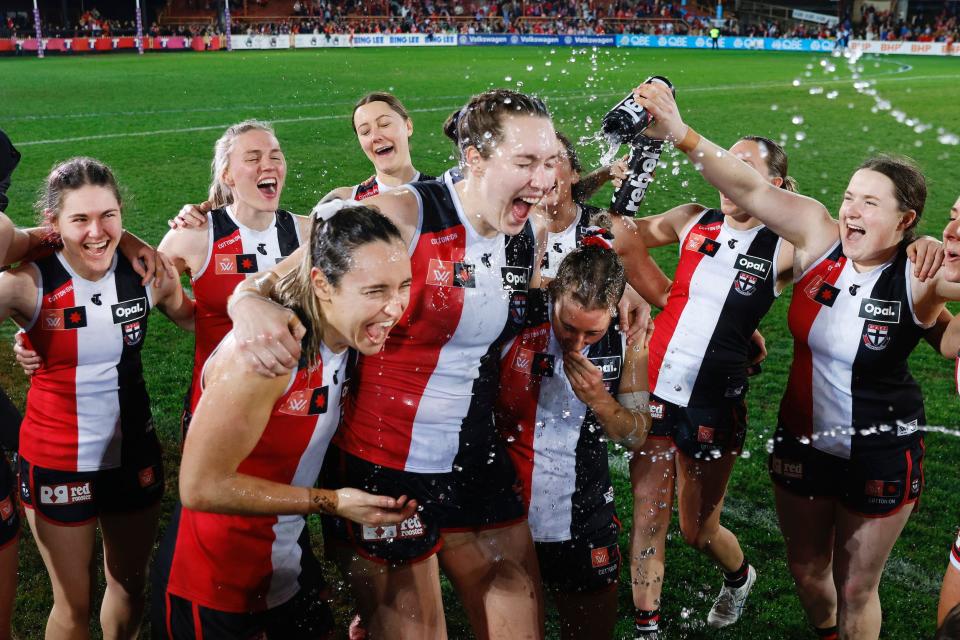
left=223, top=129, right=287, bottom=211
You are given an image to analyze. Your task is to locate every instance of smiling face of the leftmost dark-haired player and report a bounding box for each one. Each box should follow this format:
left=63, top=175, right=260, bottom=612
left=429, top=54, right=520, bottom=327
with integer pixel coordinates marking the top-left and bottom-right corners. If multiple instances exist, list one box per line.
left=52, top=185, right=123, bottom=280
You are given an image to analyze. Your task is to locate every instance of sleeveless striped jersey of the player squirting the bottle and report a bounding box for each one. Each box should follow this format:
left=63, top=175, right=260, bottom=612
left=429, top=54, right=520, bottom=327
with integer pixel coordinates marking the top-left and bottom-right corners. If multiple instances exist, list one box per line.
left=780, top=242, right=930, bottom=458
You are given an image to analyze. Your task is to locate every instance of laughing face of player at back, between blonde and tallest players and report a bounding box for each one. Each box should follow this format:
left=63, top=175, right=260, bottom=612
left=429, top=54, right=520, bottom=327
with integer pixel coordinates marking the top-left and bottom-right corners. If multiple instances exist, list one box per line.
left=353, top=100, right=413, bottom=175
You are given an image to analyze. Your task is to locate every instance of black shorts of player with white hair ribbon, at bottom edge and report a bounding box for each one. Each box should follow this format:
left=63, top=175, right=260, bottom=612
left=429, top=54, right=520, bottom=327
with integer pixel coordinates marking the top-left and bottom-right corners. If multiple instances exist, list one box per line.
left=152, top=586, right=334, bottom=640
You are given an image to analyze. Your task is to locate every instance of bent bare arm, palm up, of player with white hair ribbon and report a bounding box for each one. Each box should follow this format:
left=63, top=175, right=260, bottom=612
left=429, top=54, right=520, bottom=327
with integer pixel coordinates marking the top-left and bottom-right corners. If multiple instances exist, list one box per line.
left=180, top=339, right=416, bottom=525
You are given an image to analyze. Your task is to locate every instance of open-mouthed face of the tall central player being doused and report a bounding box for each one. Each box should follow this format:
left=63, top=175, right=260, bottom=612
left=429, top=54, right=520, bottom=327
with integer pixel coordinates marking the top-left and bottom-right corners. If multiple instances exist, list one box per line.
left=466, top=115, right=558, bottom=236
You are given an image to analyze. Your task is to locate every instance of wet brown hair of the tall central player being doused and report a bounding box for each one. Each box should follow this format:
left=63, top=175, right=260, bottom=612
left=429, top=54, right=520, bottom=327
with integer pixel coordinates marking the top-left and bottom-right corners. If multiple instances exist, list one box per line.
left=443, top=89, right=550, bottom=164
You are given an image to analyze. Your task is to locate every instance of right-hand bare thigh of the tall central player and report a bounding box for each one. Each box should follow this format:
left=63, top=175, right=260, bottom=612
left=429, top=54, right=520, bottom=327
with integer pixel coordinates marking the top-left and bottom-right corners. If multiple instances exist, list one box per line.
left=439, top=522, right=544, bottom=640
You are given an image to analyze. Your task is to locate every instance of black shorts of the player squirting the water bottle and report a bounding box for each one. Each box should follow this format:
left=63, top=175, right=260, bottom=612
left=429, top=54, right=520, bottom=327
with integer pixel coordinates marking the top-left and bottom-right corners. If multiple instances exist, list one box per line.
left=768, top=429, right=923, bottom=518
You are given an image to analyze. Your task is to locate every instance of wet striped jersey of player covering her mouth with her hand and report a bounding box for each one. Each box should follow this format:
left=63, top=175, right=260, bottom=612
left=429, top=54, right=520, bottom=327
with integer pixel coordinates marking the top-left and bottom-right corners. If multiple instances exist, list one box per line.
left=496, top=291, right=625, bottom=542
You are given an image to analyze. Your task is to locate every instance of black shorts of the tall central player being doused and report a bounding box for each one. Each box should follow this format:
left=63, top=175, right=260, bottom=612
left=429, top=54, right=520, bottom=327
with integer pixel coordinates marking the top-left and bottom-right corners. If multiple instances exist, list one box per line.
left=321, top=442, right=525, bottom=564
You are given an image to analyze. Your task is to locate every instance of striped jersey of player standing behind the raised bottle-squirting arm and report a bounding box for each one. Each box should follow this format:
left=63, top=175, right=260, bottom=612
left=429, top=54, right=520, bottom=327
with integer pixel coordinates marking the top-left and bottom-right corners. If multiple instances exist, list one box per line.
left=649, top=209, right=781, bottom=407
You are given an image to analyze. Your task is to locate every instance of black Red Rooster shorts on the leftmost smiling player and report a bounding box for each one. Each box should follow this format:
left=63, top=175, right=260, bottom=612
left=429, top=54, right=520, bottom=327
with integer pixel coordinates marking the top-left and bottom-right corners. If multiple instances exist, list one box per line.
left=19, top=431, right=164, bottom=526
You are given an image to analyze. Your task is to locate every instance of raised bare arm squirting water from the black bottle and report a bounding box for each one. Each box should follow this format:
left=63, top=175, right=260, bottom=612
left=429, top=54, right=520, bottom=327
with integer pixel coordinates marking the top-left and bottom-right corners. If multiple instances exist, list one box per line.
left=634, top=83, right=839, bottom=255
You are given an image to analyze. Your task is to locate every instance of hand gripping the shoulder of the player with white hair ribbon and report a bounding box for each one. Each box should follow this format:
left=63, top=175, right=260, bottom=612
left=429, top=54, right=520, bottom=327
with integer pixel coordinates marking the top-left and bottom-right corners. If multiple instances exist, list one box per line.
left=228, top=294, right=307, bottom=378
